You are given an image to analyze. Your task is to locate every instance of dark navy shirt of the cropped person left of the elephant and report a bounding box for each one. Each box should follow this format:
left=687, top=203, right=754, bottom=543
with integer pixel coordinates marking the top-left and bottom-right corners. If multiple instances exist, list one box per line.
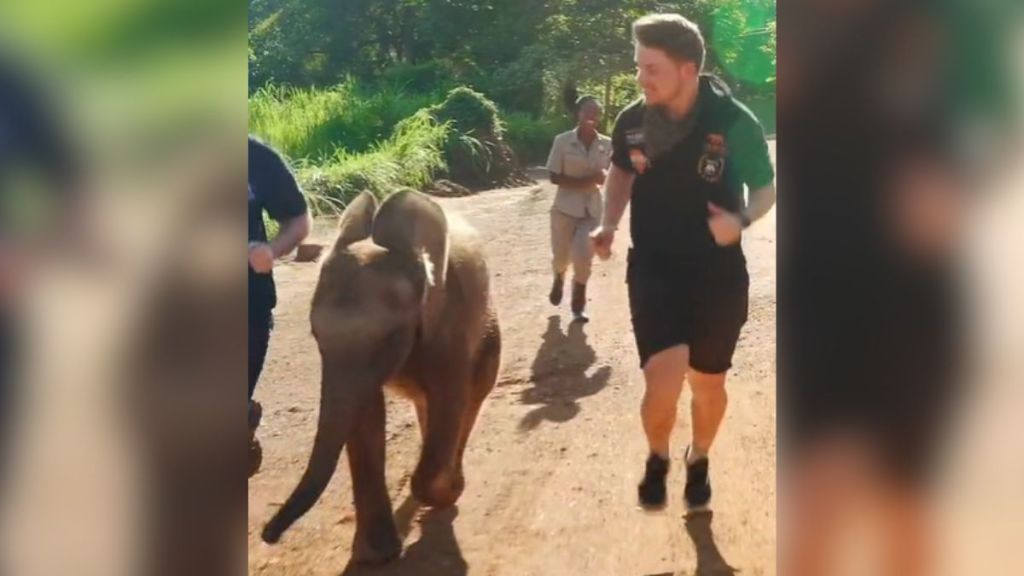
left=249, top=136, right=306, bottom=310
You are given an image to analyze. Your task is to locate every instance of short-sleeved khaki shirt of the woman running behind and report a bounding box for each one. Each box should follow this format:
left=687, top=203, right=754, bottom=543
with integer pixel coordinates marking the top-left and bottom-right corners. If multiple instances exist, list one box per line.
left=548, top=129, right=611, bottom=219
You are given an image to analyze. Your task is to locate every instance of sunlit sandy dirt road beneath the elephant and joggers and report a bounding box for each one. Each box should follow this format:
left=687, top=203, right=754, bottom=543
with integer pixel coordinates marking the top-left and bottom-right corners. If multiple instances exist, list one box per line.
left=249, top=147, right=775, bottom=576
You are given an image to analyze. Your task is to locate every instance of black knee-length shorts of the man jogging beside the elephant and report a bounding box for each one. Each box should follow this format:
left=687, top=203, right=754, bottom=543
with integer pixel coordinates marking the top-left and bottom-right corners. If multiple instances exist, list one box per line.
left=626, top=251, right=750, bottom=374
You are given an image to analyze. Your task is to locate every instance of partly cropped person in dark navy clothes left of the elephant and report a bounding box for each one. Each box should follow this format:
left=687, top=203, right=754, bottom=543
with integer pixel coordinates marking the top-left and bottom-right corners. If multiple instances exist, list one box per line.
left=249, top=136, right=310, bottom=476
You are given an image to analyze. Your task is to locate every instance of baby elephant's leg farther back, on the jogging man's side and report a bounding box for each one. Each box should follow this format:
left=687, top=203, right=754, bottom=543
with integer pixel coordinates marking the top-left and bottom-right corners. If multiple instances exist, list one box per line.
left=413, top=368, right=469, bottom=507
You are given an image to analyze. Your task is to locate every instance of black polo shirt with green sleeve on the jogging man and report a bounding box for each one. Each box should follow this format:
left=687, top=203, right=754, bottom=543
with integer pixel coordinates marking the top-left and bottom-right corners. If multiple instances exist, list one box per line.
left=611, top=76, right=775, bottom=268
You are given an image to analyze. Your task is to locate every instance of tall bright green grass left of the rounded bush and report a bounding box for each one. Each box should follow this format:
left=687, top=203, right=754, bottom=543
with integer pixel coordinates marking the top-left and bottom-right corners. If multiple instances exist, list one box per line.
left=249, top=80, right=450, bottom=214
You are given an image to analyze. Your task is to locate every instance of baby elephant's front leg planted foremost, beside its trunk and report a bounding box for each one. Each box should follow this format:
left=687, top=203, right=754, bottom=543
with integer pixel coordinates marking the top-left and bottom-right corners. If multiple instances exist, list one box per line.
left=348, top=390, right=401, bottom=564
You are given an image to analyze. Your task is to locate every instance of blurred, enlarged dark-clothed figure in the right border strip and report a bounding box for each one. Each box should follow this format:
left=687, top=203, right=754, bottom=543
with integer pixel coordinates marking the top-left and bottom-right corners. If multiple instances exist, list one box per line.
left=778, top=1, right=966, bottom=576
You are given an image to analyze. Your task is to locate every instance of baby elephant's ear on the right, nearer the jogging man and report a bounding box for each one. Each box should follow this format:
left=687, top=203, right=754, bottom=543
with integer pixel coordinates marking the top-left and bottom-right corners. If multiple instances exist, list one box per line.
left=373, top=190, right=449, bottom=334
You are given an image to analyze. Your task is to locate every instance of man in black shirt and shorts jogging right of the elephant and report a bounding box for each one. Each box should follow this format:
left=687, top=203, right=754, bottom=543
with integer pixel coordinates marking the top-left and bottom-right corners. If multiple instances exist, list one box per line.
left=592, top=14, right=775, bottom=508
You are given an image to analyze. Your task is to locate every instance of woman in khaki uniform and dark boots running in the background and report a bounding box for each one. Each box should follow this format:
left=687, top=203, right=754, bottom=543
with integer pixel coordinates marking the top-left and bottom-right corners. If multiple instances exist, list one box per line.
left=548, top=96, right=611, bottom=322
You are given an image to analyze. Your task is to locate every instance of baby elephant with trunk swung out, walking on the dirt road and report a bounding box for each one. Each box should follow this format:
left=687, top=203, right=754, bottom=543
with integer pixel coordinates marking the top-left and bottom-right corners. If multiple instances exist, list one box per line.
left=262, top=191, right=501, bottom=563
